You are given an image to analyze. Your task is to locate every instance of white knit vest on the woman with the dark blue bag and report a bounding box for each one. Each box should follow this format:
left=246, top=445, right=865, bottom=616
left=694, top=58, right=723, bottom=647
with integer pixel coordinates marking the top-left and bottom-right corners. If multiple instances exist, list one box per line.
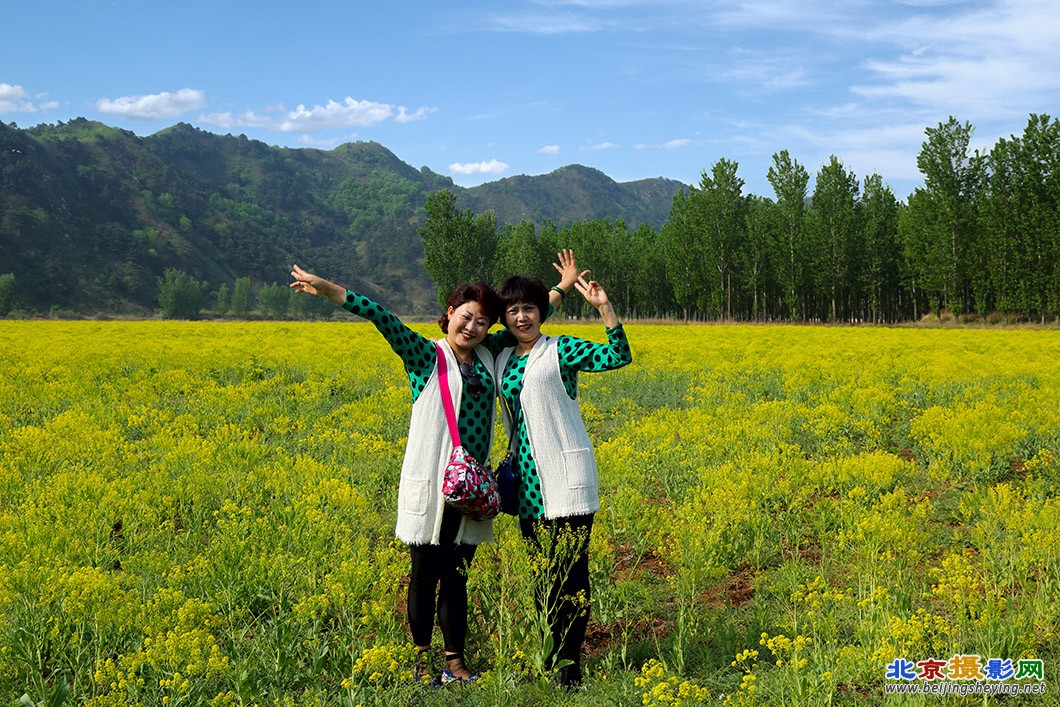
left=495, top=335, right=600, bottom=518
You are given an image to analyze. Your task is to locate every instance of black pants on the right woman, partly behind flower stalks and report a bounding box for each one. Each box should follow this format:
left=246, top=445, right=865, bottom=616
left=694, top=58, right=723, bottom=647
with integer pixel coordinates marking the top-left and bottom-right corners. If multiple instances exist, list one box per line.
left=519, top=513, right=593, bottom=666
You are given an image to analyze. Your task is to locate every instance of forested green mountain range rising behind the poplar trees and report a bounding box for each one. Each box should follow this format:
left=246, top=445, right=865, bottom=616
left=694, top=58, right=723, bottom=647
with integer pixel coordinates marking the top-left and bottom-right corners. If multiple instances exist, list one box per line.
left=0, top=119, right=682, bottom=315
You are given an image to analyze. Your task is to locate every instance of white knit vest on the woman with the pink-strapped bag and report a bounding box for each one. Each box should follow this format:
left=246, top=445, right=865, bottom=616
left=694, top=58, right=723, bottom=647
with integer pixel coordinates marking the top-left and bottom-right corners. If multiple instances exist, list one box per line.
left=395, top=339, right=493, bottom=545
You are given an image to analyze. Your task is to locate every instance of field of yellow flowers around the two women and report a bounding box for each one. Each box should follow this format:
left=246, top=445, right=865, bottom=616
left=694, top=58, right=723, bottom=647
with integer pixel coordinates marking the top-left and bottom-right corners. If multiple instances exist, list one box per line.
left=0, top=321, right=1060, bottom=707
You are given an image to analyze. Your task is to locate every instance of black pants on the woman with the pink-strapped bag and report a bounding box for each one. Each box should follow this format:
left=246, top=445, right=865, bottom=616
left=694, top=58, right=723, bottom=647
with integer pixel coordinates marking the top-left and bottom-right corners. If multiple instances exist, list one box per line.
left=408, top=506, right=475, bottom=653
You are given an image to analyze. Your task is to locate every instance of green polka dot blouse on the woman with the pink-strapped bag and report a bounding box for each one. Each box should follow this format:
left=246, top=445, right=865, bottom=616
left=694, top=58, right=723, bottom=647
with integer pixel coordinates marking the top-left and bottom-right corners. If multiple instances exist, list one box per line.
left=342, top=289, right=496, bottom=463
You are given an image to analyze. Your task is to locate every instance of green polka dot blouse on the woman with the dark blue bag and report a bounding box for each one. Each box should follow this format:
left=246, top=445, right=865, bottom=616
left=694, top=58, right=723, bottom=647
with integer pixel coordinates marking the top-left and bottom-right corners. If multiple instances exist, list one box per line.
left=500, top=324, right=633, bottom=518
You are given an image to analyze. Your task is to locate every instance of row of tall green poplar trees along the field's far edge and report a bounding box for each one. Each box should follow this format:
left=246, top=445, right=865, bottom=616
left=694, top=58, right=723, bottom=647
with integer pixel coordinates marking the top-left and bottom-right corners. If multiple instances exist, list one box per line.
left=420, top=114, right=1060, bottom=323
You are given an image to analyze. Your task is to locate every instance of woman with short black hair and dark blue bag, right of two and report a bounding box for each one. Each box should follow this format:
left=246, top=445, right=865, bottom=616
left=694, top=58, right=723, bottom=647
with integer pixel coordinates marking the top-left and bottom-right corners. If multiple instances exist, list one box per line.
left=494, top=268, right=633, bottom=687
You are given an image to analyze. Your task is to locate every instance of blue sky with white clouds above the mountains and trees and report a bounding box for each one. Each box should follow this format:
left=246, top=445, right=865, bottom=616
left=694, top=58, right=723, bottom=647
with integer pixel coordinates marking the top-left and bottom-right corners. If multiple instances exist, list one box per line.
left=0, top=0, right=1060, bottom=199
